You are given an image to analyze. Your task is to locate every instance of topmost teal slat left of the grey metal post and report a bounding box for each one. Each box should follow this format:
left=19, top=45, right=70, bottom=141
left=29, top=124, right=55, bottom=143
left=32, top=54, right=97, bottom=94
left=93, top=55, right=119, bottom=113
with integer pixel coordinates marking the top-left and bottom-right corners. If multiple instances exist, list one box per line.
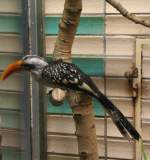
left=0, top=15, right=23, bottom=34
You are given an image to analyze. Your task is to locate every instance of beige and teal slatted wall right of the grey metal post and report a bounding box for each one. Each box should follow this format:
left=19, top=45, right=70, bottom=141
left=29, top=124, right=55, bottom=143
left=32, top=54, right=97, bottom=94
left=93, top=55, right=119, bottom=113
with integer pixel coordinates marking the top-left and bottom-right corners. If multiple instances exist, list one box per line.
left=45, top=0, right=150, bottom=160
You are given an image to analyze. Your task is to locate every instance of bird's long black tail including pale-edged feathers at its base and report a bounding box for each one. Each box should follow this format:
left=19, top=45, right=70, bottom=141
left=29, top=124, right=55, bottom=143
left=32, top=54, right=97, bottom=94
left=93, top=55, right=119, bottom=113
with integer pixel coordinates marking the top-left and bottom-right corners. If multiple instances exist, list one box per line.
left=80, top=76, right=141, bottom=141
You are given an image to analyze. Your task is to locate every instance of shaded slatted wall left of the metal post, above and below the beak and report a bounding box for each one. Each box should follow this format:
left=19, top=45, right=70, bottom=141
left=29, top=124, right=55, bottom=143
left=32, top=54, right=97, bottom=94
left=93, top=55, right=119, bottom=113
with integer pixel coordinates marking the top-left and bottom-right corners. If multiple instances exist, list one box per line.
left=0, top=0, right=24, bottom=160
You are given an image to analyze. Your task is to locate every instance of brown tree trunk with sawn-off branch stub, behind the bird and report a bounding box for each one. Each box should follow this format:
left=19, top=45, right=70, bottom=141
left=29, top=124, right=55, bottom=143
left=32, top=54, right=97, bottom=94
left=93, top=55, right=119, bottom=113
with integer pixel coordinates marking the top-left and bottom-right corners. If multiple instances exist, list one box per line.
left=48, top=0, right=98, bottom=160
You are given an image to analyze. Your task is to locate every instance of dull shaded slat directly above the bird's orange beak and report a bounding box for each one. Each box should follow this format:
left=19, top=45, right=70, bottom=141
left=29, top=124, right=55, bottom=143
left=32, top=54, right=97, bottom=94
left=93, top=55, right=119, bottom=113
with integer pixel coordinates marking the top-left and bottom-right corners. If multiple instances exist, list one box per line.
left=0, top=54, right=21, bottom=70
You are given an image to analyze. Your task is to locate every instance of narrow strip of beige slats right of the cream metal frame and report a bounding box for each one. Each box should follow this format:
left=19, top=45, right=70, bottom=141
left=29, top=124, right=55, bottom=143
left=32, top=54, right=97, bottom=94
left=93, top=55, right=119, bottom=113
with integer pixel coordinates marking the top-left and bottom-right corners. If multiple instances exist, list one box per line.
left=142, top=41, right=150, bottom=158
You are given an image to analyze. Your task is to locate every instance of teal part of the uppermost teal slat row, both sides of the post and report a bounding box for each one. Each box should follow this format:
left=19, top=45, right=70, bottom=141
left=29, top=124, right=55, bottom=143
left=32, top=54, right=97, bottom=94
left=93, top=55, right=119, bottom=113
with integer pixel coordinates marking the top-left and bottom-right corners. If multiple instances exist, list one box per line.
left=0, top=15, right=104, bottom=35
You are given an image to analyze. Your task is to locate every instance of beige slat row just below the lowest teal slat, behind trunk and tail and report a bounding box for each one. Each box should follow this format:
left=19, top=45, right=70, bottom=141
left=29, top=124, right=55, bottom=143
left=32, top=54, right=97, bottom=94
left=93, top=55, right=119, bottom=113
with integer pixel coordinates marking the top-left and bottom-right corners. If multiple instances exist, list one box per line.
left=47, top=115, right=134, bottom=137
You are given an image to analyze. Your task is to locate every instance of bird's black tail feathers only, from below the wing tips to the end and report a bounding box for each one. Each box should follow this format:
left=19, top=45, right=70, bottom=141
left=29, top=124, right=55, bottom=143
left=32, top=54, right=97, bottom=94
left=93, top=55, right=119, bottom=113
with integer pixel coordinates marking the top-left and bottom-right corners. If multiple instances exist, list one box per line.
left=95, top=92, right=141, bottom=140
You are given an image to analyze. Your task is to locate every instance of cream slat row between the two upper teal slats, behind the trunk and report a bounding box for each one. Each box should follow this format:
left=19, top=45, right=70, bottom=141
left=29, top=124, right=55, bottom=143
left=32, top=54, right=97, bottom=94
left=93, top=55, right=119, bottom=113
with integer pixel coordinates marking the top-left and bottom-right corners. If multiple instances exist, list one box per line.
left=45, top=36, right=135, bottom=57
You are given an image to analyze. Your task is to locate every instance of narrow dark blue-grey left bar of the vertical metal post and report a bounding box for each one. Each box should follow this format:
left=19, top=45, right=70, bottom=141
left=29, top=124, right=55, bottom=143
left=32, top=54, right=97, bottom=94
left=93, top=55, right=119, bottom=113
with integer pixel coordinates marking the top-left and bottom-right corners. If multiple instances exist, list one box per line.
left=22, top=0, right=32, bottom=160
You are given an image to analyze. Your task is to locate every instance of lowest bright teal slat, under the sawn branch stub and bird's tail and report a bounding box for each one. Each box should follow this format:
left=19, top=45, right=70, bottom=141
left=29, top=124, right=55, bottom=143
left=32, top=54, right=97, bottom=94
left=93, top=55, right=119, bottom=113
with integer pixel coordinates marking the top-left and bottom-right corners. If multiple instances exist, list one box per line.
left=47, top=99, right=105, bottom=116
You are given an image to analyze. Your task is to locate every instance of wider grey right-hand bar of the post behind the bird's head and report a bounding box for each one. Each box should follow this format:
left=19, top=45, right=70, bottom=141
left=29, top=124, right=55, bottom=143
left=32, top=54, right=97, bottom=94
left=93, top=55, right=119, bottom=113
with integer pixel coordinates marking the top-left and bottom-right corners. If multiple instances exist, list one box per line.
left=30, top=0, right=46, bottom=160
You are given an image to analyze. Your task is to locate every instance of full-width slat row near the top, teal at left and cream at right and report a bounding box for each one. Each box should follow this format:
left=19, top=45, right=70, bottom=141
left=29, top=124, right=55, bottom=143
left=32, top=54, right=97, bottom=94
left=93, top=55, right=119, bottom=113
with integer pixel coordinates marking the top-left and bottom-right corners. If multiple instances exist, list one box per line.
left=0, top=15, right=150, bottom=35
